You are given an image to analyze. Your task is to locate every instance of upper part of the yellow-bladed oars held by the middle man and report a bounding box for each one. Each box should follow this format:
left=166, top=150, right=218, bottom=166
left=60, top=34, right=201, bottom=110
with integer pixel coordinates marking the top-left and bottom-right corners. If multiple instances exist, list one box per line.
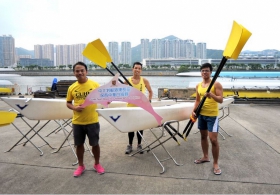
left=83, top=39, right=132, bottom=86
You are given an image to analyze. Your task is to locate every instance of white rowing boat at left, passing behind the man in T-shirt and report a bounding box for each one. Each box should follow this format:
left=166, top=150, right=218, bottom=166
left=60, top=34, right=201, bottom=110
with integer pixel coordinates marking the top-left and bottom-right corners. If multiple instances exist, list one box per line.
left=1, top=97, right=176, bottom=120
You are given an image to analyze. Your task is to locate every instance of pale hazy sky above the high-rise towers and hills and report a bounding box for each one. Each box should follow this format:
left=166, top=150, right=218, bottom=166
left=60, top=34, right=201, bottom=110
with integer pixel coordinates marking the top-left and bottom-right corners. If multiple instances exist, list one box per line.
left=0, top=0, right=280, bottom=51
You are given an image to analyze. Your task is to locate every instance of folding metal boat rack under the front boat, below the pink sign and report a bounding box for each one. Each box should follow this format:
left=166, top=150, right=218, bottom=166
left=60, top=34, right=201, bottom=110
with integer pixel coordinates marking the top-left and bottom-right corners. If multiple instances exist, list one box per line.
left=129, top=120, right=183, bottom=174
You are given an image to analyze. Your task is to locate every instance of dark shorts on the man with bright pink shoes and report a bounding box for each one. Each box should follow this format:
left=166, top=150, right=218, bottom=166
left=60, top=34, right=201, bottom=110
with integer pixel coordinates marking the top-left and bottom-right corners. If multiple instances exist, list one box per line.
left=72, top=122, right=100, bottom=146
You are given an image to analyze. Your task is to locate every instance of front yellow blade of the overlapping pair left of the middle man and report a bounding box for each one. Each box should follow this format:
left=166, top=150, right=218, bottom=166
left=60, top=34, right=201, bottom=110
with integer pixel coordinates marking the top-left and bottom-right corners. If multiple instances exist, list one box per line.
left=83, top=43, right=106, bottom=68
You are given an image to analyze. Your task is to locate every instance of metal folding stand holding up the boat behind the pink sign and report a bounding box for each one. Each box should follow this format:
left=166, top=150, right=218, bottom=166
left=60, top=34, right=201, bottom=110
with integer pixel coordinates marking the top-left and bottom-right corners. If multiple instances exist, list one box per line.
left=130, top=120, right=183, bottom=174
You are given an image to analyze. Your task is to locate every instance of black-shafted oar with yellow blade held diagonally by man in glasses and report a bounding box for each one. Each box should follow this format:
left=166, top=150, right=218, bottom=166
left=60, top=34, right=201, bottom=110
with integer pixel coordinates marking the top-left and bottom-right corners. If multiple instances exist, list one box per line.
left=183, top=21, right=252, bottom=138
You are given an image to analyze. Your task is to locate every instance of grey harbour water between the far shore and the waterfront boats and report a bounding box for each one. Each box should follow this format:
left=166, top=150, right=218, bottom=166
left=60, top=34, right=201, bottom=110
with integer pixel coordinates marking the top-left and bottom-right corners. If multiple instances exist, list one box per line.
left=0, top=76, right=280, bottom=98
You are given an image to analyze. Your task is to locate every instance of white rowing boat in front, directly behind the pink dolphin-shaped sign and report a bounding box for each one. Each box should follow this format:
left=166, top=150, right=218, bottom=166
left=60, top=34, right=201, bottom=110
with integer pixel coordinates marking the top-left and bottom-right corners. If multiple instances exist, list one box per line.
left=97, top=98, right=234, bottom=133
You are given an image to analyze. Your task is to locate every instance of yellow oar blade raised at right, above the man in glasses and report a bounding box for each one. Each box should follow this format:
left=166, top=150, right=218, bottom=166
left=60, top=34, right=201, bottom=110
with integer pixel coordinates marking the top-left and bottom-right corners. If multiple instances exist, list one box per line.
left=223, top=21, right=252, bottom=60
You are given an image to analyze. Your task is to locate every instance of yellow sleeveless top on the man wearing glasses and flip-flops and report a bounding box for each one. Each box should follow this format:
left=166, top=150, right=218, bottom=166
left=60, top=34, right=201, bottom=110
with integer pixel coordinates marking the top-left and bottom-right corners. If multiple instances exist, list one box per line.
left=197, top=82, right=219, bottom=116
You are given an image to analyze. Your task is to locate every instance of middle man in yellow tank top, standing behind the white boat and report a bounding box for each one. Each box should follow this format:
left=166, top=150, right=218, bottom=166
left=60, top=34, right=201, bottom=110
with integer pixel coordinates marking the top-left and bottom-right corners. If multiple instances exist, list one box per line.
left=125, top=62, right=153, bottom=154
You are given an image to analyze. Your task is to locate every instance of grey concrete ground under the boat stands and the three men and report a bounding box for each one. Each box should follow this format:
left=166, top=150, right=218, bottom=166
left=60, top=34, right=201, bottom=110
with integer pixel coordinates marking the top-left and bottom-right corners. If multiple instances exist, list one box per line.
left=0, top=100, right=280, bottom=194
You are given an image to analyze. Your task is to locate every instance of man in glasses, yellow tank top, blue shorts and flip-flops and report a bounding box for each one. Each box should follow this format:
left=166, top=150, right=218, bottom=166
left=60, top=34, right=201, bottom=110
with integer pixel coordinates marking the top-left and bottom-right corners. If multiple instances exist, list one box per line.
left=193, top=63, right=223, bottom=175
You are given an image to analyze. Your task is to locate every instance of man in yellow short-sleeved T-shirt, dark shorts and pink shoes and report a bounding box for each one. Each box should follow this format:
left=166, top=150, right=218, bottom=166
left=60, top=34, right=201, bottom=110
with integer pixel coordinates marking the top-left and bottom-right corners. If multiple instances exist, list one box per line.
left=66, top=62, right=105, bottom=177
